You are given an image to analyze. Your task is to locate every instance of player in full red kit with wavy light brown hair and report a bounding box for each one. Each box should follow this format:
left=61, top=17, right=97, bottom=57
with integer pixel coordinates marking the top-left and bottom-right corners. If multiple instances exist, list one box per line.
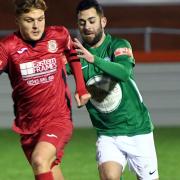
left=0, top=0, right=90, bottom=180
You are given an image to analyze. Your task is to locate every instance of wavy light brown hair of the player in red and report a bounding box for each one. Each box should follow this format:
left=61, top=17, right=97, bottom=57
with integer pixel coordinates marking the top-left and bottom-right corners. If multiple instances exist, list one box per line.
left=14, top=0, right=47, bottom=16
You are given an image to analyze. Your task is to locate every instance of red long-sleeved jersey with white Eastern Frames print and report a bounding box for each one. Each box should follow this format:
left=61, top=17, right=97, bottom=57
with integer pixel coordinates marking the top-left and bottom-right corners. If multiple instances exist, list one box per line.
left=0, top=26, right=87, bottom=134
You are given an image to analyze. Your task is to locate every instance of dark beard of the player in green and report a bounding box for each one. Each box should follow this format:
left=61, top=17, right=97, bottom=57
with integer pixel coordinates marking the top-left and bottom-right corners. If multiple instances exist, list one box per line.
left=83, top=27, right=103, bottom=46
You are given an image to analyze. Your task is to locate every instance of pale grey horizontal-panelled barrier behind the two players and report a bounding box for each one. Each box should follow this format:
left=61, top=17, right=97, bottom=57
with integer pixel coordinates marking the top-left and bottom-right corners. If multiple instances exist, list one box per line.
left=0, top=63, right=180, bottom=128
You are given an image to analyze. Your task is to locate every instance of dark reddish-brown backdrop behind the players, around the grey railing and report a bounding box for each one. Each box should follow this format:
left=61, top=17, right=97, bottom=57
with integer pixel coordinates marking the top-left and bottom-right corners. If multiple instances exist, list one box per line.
left=0, top=0, right=180, bottom=51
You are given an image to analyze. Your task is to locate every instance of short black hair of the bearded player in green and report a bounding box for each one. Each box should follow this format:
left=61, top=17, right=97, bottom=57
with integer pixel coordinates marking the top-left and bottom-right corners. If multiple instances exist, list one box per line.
left=76, top=0, right=104, bottom=16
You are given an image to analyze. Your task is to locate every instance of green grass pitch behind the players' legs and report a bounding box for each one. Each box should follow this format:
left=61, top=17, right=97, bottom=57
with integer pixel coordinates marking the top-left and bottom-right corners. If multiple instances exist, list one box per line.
left=0, top=127, right=180, bottom=180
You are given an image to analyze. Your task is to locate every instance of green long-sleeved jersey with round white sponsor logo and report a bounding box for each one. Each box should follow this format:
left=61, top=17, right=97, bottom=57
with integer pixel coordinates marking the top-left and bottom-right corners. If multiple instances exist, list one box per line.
left=67, top=34, right=153, bottom=136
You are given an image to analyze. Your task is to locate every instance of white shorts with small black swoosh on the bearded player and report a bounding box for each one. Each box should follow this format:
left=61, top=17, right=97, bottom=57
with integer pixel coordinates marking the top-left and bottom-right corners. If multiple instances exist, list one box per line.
left=96, top=132, right=159, bottom=180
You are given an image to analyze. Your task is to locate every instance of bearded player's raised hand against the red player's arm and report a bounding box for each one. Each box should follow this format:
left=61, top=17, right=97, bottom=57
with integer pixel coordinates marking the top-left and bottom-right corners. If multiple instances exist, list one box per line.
left=74, top=38, right=94, bottom=63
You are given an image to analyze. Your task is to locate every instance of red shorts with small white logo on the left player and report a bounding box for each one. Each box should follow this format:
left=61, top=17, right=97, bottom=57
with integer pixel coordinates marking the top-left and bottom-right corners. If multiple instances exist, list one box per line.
left=21, top=124, right=73, bottom=168
